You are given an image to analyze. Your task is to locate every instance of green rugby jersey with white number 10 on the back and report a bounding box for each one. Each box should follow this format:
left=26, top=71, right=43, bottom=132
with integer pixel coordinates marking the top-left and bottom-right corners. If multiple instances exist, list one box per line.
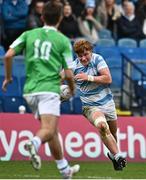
left=10, top=26, right=73, bottom=94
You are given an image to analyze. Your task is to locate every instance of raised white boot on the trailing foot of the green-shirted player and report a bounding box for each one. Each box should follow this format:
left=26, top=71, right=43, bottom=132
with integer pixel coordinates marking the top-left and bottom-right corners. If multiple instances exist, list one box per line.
left=25, top=141, right=41, bottom=170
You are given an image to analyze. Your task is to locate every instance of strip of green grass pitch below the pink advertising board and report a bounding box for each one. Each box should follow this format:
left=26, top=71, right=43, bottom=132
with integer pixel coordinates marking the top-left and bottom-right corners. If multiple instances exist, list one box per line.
left=0, top=161, right=146, bottom=179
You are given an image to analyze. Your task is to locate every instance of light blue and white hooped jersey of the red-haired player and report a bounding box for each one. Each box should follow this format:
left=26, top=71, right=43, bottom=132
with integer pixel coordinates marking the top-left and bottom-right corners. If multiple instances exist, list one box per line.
left=72, top=53, right=113, bottom=106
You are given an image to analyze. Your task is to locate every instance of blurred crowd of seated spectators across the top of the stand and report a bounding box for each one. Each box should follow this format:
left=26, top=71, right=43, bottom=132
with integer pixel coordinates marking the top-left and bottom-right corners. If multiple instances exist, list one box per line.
left=0, top=0, right=146, bottom=50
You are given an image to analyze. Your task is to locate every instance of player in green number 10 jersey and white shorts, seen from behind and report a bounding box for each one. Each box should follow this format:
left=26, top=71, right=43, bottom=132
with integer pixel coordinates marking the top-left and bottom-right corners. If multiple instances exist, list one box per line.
left=2, top=0, right=80, bottom=179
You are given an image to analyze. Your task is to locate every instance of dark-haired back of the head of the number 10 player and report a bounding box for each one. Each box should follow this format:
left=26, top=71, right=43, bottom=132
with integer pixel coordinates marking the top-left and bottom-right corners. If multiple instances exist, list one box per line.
left=42, top=0, right=63, bottom=25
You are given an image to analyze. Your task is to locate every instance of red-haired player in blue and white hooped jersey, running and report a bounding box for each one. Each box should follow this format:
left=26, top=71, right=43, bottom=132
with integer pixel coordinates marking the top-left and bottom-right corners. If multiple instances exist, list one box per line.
left=72, top=40, right=126, bottom=170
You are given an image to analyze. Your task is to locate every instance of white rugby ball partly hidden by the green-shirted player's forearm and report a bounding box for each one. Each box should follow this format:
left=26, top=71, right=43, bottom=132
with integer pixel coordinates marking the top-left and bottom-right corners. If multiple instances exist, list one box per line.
left=60, top=84, right=71, bottom=101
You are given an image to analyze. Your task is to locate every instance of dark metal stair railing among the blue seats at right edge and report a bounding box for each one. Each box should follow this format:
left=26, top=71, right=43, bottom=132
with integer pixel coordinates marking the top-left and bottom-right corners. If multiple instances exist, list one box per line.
left=120, top=54, right=146, bottom=115
